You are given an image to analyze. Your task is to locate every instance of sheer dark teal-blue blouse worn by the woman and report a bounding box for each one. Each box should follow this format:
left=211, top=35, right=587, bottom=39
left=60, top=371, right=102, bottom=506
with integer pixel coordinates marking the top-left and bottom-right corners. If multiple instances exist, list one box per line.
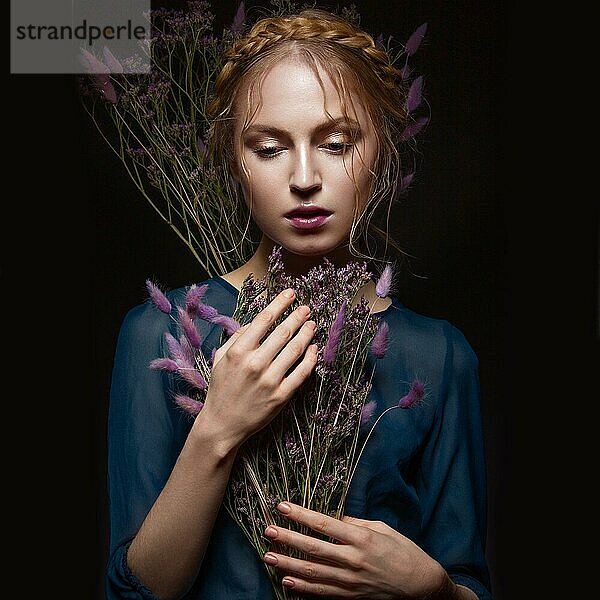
left=106, top=276, right=492, bottom=600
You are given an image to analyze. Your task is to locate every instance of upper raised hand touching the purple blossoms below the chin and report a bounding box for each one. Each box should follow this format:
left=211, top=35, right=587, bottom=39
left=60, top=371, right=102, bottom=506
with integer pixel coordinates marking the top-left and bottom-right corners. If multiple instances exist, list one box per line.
left=194, top=292, right=317, bottom=448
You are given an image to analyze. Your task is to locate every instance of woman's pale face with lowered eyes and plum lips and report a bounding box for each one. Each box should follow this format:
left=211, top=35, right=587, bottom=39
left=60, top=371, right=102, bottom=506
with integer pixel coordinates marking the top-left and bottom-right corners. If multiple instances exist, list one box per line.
left=236, top=59, right=377, bottom=256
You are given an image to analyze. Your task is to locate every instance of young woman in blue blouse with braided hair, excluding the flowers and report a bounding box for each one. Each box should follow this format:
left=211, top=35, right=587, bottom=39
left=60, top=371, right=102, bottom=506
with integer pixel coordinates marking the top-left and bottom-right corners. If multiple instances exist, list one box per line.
left=107, top=5, right=491, bottom=600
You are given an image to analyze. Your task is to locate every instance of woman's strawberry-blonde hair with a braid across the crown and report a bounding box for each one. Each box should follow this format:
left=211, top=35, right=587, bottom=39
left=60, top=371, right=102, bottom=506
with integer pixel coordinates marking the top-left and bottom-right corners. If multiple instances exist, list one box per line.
left=207, top=9, right=408, bottom=260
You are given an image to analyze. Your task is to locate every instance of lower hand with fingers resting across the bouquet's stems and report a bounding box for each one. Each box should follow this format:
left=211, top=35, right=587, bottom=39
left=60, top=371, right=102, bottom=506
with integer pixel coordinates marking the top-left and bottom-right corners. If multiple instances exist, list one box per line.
left=263, top=502, right=447, bottom=600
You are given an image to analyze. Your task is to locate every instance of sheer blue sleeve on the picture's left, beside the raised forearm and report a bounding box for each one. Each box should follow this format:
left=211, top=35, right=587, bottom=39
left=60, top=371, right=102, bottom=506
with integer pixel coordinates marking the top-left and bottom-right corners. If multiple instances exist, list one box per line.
left=106, top=303, right=190, bottom=600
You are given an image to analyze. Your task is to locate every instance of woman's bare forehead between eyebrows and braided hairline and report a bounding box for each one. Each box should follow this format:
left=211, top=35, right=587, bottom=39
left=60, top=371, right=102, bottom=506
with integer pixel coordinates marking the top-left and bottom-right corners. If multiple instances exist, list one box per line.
left=236, top=57, right=370, bottom=128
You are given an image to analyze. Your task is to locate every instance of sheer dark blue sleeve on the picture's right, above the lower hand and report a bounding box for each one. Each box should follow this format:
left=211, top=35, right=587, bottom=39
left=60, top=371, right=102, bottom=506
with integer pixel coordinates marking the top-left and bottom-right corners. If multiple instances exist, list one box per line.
left=416, top=323, right=492, bottom=600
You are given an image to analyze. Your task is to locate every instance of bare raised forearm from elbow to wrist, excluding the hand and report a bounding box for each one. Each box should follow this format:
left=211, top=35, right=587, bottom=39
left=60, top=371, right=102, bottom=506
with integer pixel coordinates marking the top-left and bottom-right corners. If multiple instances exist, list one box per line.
left=127, top=413, right=236, bottom=600
